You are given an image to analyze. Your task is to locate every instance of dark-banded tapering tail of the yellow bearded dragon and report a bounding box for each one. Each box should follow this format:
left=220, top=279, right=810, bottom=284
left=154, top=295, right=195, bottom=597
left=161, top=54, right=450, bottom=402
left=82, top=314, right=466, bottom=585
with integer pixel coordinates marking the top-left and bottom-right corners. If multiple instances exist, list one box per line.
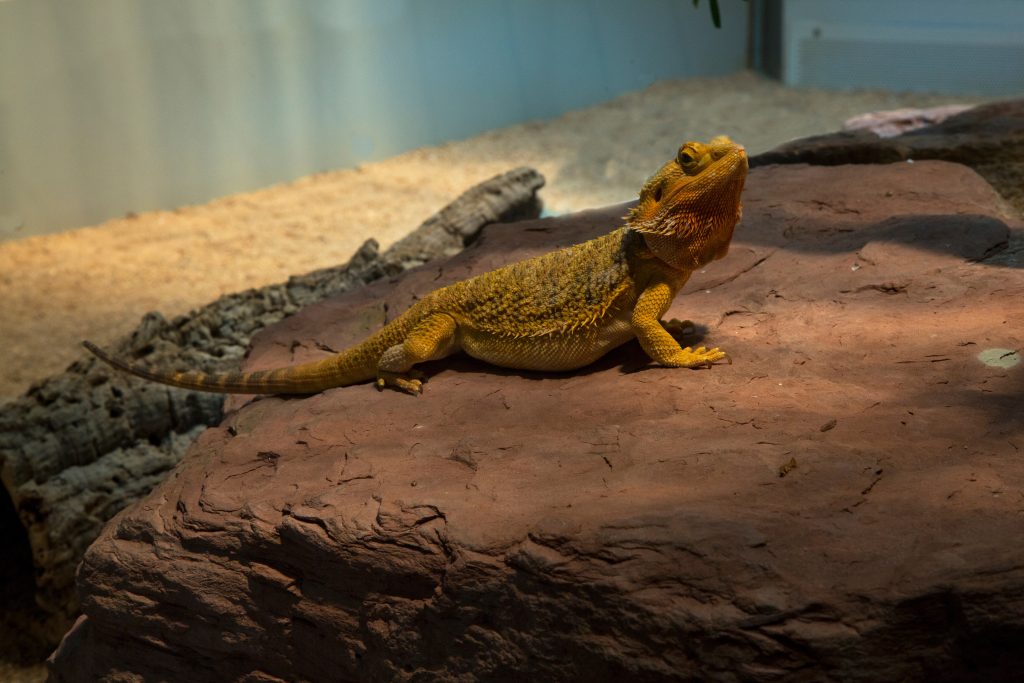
left=82, top=341, right=376, bottom=394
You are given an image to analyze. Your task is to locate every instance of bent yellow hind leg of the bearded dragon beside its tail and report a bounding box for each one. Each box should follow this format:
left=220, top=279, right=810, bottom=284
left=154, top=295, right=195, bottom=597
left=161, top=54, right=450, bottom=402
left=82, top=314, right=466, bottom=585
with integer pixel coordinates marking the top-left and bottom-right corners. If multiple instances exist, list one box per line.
left=377, top=313, right=458, bottom=394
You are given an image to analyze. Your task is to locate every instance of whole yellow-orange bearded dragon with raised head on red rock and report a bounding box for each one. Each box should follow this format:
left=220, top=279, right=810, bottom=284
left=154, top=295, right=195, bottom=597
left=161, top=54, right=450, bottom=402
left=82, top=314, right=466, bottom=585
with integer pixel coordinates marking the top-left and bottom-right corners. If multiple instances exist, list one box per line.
left=83, top=136, right=748, bottom=394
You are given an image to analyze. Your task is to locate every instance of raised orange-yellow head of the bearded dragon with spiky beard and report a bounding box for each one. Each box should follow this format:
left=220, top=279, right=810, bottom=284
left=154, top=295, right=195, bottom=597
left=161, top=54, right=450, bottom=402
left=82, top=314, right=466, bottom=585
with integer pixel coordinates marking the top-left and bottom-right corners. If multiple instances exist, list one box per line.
left=627, top=135, right=746, bottom=270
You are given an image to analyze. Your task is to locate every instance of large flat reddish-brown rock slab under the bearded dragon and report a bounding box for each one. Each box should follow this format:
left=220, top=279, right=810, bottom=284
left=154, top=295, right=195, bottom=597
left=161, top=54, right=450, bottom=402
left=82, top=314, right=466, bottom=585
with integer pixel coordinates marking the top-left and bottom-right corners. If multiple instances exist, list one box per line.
left=52, top=162, right=1024, bottom=681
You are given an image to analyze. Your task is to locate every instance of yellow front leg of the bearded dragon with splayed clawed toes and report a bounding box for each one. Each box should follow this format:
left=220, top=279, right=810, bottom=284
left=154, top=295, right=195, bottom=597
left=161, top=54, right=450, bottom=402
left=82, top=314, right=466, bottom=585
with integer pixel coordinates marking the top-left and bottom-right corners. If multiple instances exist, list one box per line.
left=630, top=283, right=728, bottom=368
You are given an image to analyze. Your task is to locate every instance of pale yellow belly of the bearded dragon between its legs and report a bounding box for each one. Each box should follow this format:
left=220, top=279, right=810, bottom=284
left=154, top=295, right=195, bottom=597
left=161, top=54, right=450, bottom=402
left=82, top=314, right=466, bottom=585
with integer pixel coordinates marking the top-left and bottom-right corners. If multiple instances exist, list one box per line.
left=459, top=314, right=635, bottom=371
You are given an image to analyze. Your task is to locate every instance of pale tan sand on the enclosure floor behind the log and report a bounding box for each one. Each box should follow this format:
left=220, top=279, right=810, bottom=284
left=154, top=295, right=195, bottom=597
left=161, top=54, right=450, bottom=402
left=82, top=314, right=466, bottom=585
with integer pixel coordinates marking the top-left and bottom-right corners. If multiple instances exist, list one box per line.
left=0, top=73, right=984, bottom=401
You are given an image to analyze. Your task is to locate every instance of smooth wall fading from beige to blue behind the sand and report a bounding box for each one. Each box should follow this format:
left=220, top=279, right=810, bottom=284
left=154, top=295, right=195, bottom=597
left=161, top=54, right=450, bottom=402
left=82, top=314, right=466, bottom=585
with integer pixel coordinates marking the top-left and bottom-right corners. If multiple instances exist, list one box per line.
left=0, top=0, right=748, bottom=239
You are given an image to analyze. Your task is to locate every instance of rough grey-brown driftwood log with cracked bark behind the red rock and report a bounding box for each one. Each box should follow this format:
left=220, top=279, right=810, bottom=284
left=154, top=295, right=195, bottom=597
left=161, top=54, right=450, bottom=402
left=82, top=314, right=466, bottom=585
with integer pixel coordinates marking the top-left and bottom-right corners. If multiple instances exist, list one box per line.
left=0, top=168, right=544, bottom=647
